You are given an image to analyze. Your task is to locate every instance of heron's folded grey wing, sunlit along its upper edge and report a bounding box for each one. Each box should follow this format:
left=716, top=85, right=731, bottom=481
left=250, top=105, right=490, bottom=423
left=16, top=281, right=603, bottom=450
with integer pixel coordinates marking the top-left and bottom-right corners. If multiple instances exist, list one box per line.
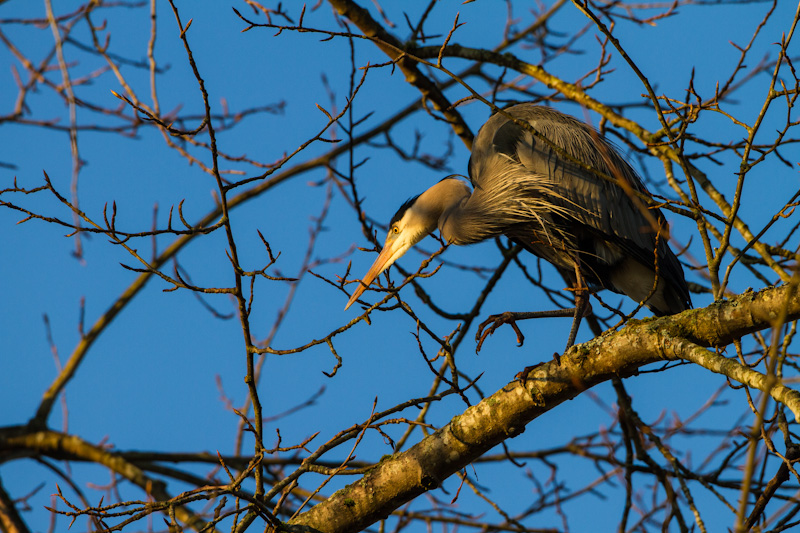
left=469, top=104, right=689, bottom=310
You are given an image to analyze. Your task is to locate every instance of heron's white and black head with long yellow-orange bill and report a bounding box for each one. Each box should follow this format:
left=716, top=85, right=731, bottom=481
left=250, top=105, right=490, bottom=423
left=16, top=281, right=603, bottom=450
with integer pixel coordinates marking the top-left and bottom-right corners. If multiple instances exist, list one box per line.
left=345, top=189, right=441, bottom=310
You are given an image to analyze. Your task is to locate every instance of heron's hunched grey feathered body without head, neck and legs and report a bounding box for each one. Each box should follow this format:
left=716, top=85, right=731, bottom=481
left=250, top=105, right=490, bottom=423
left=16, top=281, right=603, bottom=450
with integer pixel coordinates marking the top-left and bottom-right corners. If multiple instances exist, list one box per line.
left=462, top=104, right=691, bottom=315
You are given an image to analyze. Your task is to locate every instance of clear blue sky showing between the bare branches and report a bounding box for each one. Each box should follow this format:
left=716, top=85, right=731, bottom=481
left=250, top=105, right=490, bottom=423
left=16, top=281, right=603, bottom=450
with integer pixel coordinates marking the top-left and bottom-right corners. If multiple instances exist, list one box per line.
left=0, top=0, right=798, bottom=531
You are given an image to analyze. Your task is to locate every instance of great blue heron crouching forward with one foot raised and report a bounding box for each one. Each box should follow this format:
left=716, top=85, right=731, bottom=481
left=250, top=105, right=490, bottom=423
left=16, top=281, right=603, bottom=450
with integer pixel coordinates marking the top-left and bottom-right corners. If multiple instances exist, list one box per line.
left=345, top=103, right=691, bottom=348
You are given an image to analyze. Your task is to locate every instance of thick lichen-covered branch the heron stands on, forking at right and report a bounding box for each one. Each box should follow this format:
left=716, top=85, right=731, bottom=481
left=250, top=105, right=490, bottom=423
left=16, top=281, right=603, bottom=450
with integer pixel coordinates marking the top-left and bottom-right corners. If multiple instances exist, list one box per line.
left=290, top=285, right=800, bottom=533
